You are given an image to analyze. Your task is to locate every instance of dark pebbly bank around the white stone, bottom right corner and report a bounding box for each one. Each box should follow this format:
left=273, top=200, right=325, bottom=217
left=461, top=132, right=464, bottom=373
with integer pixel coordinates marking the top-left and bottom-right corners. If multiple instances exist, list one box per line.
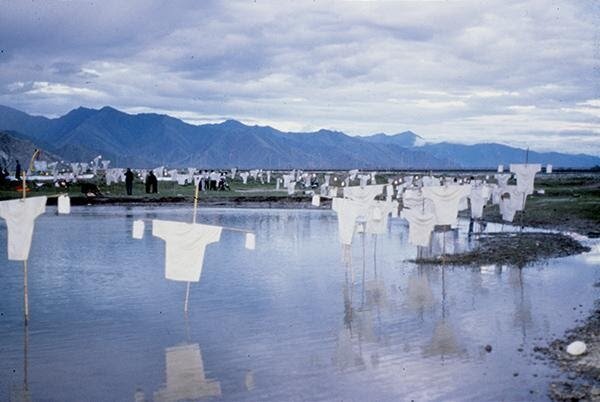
left=534, top=304, right=600, bottom=401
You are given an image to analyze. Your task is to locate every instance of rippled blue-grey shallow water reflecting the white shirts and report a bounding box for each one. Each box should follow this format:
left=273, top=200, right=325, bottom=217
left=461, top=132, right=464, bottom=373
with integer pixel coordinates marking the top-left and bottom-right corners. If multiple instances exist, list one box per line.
left=0, top=206, right=600, bottom=401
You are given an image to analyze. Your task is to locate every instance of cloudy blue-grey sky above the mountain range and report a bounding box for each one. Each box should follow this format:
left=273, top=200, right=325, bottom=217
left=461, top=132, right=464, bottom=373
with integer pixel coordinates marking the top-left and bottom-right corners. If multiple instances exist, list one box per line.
left=0, top=0, right=600, bottom=155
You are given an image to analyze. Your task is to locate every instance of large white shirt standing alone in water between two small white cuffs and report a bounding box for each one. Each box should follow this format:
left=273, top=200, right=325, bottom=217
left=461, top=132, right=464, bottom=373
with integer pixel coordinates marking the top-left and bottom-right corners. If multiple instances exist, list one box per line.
left=152, top=219, right=222, bottom=282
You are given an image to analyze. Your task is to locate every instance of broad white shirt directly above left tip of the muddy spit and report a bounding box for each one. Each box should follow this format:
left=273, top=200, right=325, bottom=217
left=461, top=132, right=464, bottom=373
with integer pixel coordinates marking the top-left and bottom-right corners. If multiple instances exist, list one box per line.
left=422, top=184, right=471, bottom=225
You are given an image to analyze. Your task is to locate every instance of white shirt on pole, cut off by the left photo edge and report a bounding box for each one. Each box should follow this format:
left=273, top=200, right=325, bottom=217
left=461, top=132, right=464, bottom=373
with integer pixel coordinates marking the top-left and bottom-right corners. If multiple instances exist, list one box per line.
left=0, top=197, right=47, bottom=261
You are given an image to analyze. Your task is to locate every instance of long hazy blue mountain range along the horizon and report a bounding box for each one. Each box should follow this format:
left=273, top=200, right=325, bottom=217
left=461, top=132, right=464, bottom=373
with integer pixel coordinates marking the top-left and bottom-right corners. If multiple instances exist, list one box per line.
left=0, top=106, right=600, bottom=169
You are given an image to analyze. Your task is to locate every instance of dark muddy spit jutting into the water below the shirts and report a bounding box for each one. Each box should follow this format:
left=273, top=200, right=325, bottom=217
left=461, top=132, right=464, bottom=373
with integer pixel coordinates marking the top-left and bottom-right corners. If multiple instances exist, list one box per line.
left=414, top=232, right=590, bottom=267
